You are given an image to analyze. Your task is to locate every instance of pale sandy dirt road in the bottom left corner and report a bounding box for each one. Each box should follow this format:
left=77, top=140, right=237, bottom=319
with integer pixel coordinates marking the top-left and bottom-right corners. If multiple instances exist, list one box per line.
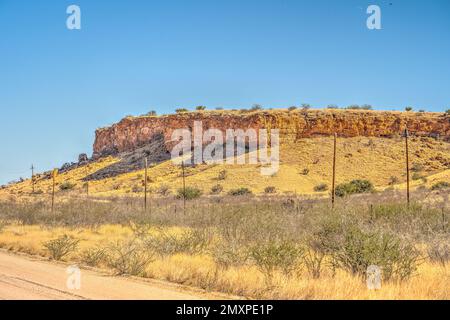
left=0, top=251, right=207, bottom=300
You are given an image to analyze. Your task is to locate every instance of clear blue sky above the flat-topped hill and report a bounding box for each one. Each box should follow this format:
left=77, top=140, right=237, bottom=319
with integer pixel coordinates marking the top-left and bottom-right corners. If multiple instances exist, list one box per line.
left=0, top=0, right=450, bottom=184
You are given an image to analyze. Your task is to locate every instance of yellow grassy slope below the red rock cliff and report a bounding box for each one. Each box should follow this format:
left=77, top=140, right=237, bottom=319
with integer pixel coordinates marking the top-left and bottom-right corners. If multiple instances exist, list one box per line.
left=0, top=137, right=450, bottom=198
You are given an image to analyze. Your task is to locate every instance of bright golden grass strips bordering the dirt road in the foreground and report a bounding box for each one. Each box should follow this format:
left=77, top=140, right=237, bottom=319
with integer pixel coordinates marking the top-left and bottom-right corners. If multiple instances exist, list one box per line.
left=0, top=225, right=450, bottom=299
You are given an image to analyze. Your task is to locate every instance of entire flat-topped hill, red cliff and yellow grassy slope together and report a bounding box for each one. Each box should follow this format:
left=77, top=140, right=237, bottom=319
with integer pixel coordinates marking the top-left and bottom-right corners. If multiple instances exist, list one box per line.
left=0, top=110, right=450, bottom=198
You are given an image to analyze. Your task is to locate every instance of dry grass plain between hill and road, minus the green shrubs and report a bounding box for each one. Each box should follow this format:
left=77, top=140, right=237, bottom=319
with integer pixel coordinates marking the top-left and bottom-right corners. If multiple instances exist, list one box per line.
left=0, top=192, right=450, bottom=299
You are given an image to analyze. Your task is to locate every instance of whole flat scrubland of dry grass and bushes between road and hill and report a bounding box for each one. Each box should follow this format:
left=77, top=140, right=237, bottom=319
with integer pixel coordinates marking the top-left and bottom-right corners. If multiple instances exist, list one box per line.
left=0, top=189, right=450, bottom=299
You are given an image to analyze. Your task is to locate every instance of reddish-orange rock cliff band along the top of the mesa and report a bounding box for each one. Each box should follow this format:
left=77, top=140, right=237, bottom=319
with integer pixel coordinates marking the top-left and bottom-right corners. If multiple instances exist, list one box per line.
left=93, top=109, right=450, bottom=158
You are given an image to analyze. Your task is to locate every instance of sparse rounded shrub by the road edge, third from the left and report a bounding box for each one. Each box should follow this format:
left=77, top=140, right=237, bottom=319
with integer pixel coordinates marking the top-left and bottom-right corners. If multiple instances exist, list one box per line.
left=107, top=239, right=153, bottom=276
